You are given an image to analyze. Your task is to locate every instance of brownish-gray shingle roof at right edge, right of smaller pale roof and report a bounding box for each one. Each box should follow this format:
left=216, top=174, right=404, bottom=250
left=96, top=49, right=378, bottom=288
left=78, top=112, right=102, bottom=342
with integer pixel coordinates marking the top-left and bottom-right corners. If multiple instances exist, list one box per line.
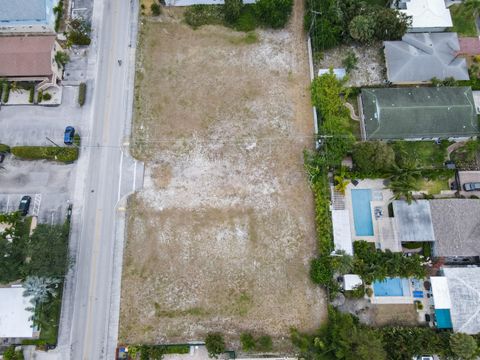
left=430, top=199, right=480, bottom=256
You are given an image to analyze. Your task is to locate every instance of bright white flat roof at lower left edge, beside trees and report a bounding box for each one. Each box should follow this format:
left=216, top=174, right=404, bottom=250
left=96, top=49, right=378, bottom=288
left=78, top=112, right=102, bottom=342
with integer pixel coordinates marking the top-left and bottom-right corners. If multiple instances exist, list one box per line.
left=0, top=287, right=33, bottom=338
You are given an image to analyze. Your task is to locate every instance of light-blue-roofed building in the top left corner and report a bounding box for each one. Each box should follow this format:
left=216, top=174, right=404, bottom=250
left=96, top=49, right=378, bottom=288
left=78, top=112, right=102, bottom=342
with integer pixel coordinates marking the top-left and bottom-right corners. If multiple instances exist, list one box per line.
left=0, top=0, right=58, bottom=35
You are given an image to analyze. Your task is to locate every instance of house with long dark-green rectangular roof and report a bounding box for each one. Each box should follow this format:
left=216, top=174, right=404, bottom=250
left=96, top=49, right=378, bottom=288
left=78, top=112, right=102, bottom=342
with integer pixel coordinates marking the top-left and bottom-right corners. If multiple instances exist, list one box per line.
left=360, top=87, right=480, bottom=141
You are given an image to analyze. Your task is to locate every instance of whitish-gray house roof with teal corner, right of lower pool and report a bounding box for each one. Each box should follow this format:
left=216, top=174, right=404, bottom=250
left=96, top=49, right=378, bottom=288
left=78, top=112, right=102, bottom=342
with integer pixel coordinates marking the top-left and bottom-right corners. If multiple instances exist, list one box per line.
left=430, top=267, right=480, bottom=335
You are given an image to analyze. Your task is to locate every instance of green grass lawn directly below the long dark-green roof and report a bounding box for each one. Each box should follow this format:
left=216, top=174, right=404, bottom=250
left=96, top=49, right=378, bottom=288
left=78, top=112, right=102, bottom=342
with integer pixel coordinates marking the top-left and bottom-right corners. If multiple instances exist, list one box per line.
left=391, top=141, right=451, bottom=169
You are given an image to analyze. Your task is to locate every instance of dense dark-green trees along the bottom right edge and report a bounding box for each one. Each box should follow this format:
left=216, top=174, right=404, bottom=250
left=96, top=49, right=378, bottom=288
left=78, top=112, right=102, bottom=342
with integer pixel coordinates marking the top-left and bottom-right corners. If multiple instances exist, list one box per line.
left=291, top=307, right=479, bottom=360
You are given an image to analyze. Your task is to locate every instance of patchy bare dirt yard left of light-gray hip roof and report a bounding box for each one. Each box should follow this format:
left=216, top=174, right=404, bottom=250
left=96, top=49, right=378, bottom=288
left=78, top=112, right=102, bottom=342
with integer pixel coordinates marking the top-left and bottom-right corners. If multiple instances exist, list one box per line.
left=315, top=43, right=386, bottom=86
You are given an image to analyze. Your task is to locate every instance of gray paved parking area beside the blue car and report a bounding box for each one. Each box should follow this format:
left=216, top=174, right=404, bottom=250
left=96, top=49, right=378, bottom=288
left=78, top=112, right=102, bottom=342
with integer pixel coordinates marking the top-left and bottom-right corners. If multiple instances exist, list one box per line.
left=0, top=86, right=88, bottom=146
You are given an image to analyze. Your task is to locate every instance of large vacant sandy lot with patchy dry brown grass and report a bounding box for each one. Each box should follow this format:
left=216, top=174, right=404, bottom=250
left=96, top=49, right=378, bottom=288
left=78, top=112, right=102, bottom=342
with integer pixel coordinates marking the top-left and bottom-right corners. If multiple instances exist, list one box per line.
left=120, top=4, right=326, bottom=349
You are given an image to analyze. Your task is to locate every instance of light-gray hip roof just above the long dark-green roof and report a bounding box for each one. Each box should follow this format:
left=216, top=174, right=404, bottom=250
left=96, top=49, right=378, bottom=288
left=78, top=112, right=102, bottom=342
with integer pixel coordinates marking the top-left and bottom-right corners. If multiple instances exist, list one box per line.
left=383, top=33, right=469, bottom=83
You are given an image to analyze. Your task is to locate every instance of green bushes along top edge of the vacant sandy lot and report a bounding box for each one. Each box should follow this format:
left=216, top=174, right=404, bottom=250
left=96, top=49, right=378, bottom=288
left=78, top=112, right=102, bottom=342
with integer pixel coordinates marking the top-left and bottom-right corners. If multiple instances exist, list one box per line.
left=185, top=0, right=293, bottom=32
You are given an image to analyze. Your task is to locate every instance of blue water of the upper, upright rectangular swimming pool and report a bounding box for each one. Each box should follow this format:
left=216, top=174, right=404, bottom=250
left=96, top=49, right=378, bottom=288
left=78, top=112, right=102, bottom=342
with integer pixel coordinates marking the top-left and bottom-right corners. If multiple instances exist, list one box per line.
left=352, top=189, right=373, bottom=236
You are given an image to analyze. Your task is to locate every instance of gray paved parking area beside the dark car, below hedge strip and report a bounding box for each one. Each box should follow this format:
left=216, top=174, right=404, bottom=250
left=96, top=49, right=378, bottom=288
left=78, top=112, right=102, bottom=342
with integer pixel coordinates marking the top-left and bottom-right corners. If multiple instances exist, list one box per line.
left=0, top=156, right=75, bottom=224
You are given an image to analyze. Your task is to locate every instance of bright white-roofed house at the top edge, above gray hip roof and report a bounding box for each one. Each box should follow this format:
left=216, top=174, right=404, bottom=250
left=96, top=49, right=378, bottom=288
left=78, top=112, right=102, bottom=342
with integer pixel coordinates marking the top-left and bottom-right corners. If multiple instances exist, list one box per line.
left=393, top=0, right=453, bottom=32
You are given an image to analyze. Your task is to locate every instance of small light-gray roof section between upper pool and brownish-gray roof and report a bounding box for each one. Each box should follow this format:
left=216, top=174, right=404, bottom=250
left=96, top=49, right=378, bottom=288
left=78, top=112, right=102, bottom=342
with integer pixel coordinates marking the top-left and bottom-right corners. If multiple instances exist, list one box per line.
left=393, top=200, right=435, bottom=241
